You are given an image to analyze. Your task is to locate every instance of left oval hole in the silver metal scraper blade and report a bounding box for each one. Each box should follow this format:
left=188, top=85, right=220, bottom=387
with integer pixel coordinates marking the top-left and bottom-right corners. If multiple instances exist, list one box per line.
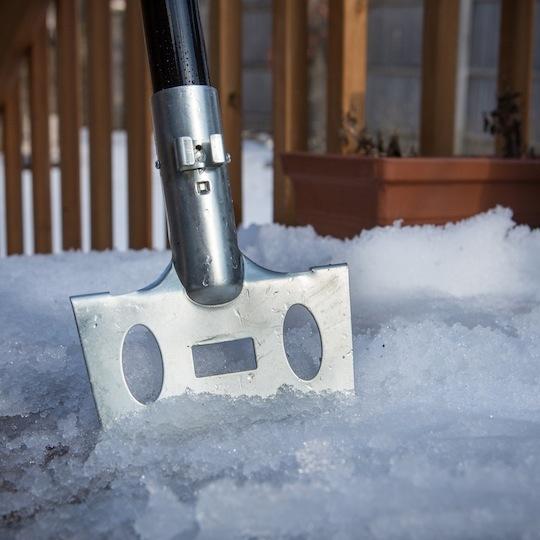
left=122, top=324, right=163, bottom=404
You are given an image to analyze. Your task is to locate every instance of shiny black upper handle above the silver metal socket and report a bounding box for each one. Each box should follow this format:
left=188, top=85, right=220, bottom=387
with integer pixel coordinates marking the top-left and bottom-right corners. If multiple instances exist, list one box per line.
left=141, top=0, right=210, bottom=92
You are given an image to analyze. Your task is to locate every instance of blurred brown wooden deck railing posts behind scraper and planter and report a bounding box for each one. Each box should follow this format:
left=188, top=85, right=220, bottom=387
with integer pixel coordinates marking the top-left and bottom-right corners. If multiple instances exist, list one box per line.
left=0, top=0, right=534, bottom=254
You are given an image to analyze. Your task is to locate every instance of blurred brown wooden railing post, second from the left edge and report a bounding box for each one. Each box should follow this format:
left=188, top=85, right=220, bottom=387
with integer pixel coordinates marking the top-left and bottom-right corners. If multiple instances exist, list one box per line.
left=30, top=20, right=52, bottom=253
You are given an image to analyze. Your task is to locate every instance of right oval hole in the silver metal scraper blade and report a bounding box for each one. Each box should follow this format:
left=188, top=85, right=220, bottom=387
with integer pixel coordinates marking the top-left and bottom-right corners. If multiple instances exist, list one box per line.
left=283, top=304, right=322, bottom=381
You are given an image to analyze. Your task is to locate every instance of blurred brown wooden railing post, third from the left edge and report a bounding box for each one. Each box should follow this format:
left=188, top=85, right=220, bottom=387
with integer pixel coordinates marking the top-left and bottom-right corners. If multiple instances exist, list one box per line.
left=56, top=0, right=81, bottom=250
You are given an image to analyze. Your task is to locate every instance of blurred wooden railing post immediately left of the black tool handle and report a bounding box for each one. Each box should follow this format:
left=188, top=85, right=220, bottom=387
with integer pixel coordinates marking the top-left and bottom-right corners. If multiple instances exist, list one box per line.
left=124, top=0, right=152, bottom=249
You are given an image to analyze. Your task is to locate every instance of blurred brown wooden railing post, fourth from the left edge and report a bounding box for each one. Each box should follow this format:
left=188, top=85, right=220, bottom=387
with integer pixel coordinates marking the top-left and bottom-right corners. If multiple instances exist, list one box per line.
left=86, top=0, right=112, bottom=250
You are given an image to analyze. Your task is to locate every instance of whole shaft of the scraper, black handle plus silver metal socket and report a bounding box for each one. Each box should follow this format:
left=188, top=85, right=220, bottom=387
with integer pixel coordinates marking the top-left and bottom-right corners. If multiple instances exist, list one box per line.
left=142, top=0, right=244, bottom=305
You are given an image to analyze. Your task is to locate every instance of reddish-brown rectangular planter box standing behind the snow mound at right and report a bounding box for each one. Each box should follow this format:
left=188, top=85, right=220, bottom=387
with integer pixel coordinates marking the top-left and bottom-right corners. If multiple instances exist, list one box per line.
left=282, top=153, right=540, bottom=238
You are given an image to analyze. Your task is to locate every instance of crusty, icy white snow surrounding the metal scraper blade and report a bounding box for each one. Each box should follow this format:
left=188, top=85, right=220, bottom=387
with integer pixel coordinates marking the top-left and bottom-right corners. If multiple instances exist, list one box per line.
left=0, top=209, right=540, bottom=539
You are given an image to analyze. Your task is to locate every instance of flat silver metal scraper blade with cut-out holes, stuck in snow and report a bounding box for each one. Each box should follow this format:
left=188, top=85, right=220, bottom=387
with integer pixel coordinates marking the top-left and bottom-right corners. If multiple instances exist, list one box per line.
left=71, top=256, right=354, bottom=427
